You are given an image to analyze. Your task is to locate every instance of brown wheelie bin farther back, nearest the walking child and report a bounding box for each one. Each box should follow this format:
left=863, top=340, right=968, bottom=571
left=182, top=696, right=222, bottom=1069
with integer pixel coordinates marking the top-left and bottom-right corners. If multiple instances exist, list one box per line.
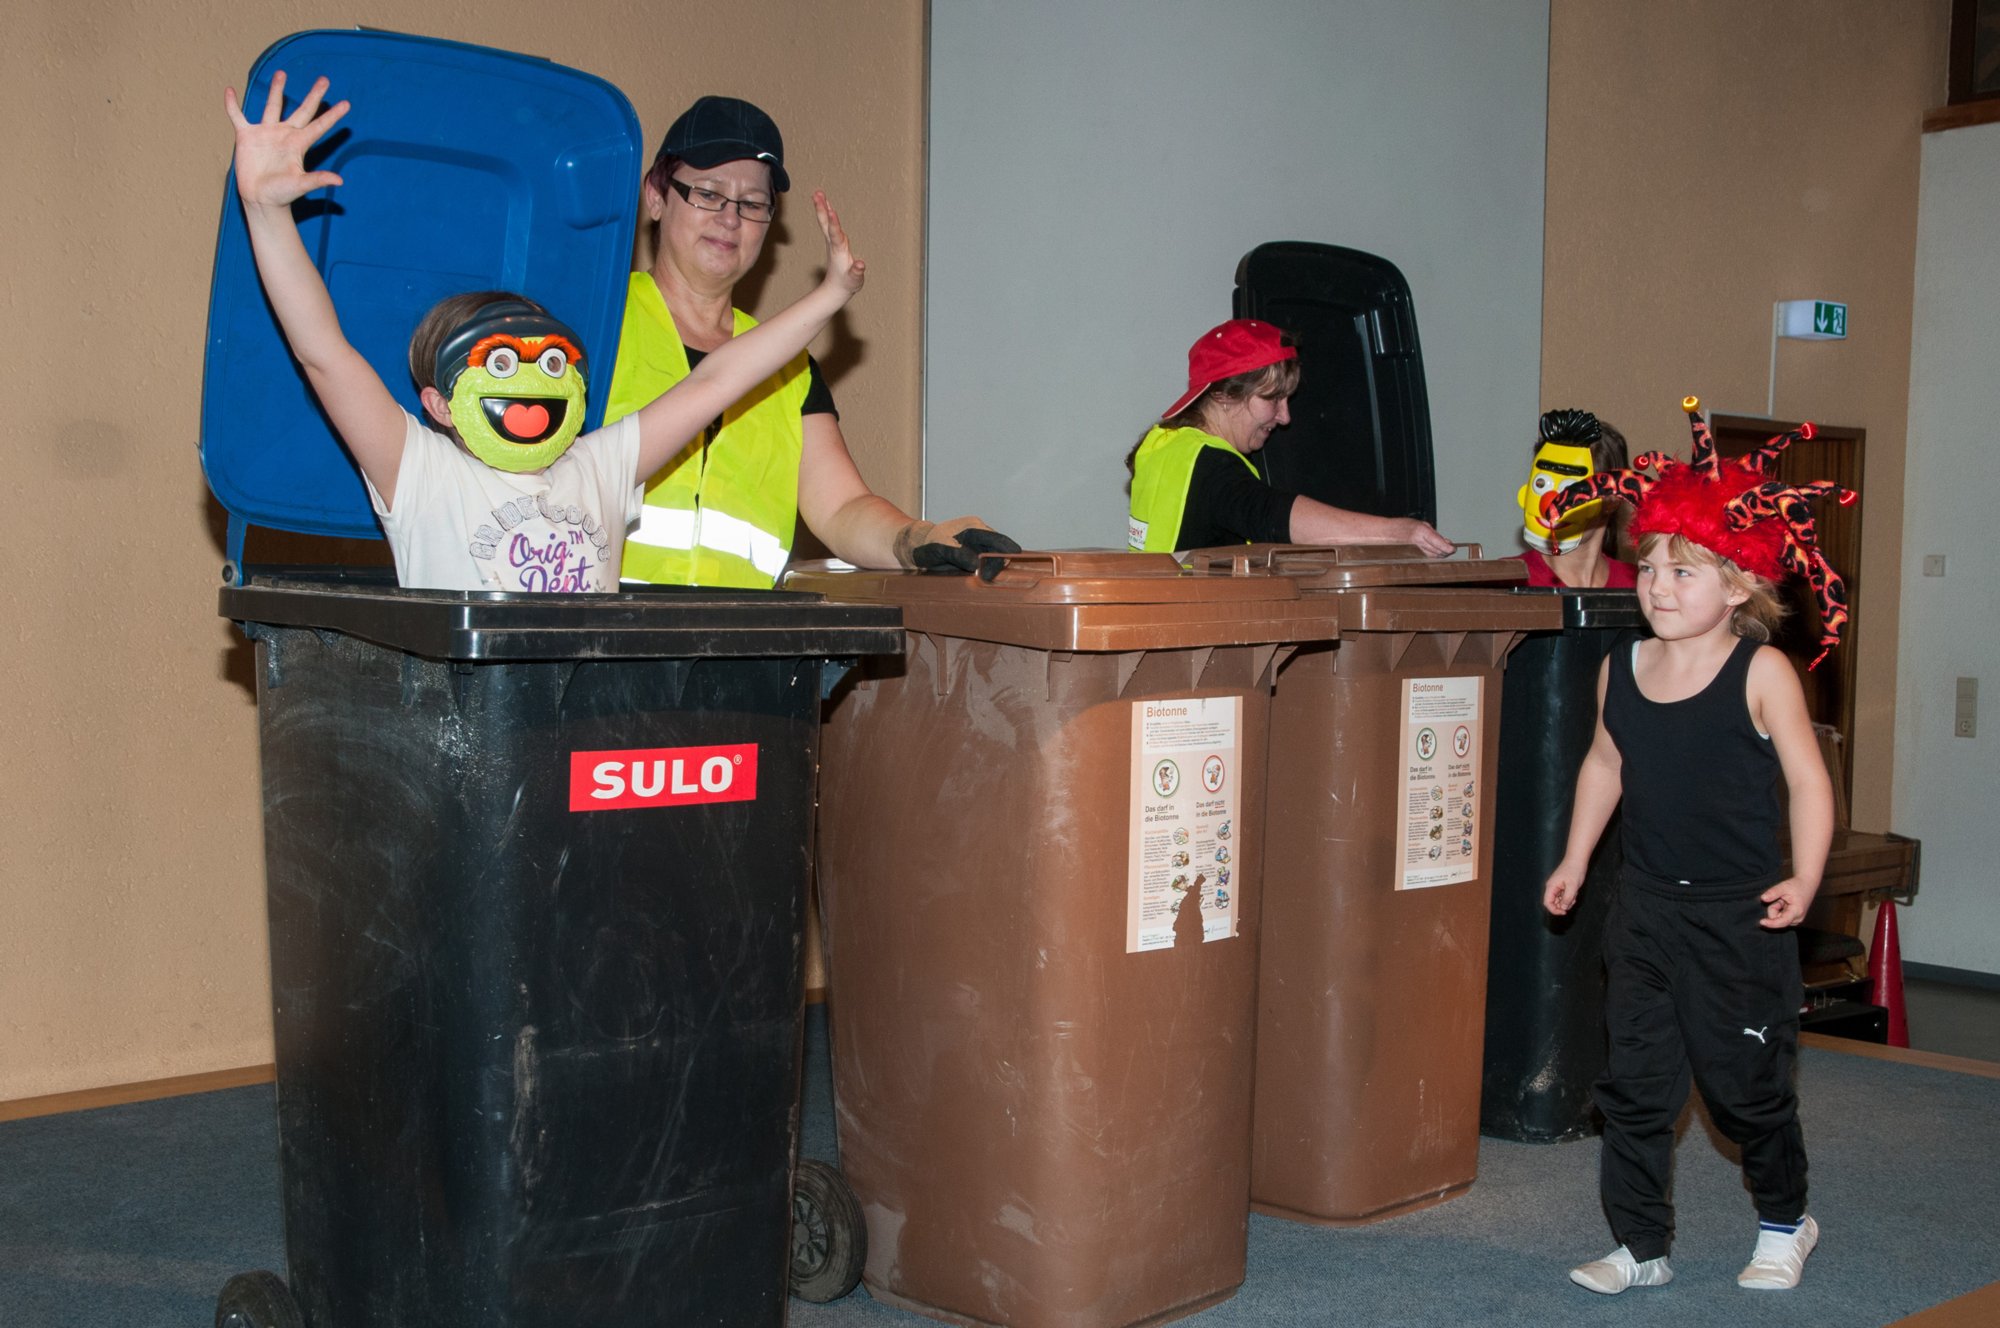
left=1192, top=546, right=1562, bottom=1226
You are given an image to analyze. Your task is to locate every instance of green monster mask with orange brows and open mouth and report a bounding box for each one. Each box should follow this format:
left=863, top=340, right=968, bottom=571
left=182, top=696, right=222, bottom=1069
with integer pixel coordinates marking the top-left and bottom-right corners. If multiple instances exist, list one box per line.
left=436, top=300, right=584, bottom=474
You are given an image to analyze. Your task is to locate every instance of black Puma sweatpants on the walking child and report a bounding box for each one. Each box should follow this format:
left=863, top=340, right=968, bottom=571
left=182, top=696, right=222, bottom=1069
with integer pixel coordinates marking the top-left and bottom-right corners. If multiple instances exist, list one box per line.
left=1594, top=872, right=1806, bottom=1262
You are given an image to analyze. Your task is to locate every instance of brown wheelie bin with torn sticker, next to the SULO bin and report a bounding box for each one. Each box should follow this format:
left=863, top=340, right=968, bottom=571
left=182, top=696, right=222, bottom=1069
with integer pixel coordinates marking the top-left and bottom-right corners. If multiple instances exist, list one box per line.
left=786, top=552, right=1332, bottom=1328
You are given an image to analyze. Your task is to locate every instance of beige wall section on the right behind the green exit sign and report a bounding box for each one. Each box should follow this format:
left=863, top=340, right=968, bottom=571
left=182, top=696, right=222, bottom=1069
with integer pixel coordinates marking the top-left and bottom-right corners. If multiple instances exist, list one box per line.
left=1542, top=0, right=1950, bottom=830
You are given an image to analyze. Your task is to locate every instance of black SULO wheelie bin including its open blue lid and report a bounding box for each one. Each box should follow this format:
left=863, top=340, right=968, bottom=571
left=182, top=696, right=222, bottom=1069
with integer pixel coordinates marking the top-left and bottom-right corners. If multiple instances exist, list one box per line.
left=202, top=32, right=902, bottom=1328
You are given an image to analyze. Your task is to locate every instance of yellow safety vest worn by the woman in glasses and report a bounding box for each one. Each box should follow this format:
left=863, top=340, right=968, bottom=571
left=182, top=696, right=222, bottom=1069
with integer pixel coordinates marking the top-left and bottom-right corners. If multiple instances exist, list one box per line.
left=604, top=272, right=810, bottom=590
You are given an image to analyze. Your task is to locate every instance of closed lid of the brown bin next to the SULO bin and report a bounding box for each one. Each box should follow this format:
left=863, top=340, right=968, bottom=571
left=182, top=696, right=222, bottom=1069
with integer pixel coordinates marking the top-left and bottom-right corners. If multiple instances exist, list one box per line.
left=784, top=550, right=1340, bottom=652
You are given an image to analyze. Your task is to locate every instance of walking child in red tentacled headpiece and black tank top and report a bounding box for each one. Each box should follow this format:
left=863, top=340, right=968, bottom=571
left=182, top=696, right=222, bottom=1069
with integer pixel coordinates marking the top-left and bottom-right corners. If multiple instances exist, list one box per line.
left=1542, top=396, right=1854, bottom=1294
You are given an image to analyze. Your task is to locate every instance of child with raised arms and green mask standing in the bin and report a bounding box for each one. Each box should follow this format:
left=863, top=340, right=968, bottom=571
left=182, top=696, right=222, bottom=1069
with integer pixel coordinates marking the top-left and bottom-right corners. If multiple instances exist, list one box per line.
left=224, top=72, right=864, bottom=592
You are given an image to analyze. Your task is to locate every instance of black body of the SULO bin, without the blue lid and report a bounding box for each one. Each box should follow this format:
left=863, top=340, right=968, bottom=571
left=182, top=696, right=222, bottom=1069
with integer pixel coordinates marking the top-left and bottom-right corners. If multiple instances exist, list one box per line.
left=222, top=576, right=900, bottom=1328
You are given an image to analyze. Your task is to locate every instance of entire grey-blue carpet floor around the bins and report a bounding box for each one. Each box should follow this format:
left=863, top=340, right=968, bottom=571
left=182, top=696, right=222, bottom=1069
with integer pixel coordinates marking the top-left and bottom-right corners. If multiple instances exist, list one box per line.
left=0, top=1014, right=2000, bottom=1328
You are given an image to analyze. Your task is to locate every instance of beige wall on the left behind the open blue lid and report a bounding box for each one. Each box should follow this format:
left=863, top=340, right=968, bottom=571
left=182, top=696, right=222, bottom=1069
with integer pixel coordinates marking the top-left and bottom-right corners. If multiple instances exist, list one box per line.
left=0, top=0, right=924, bottom=1100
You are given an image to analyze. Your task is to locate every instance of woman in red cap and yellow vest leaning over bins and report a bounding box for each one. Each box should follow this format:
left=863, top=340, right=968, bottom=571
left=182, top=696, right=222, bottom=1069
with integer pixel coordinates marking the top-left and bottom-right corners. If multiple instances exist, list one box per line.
left=1126, top=318, right=1454, bottom=556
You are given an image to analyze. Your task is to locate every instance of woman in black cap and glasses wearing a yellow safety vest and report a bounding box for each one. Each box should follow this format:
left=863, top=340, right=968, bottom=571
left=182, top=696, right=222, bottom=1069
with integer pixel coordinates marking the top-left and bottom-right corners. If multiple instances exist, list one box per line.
left=604, top=96, right=1018, bottom=588
